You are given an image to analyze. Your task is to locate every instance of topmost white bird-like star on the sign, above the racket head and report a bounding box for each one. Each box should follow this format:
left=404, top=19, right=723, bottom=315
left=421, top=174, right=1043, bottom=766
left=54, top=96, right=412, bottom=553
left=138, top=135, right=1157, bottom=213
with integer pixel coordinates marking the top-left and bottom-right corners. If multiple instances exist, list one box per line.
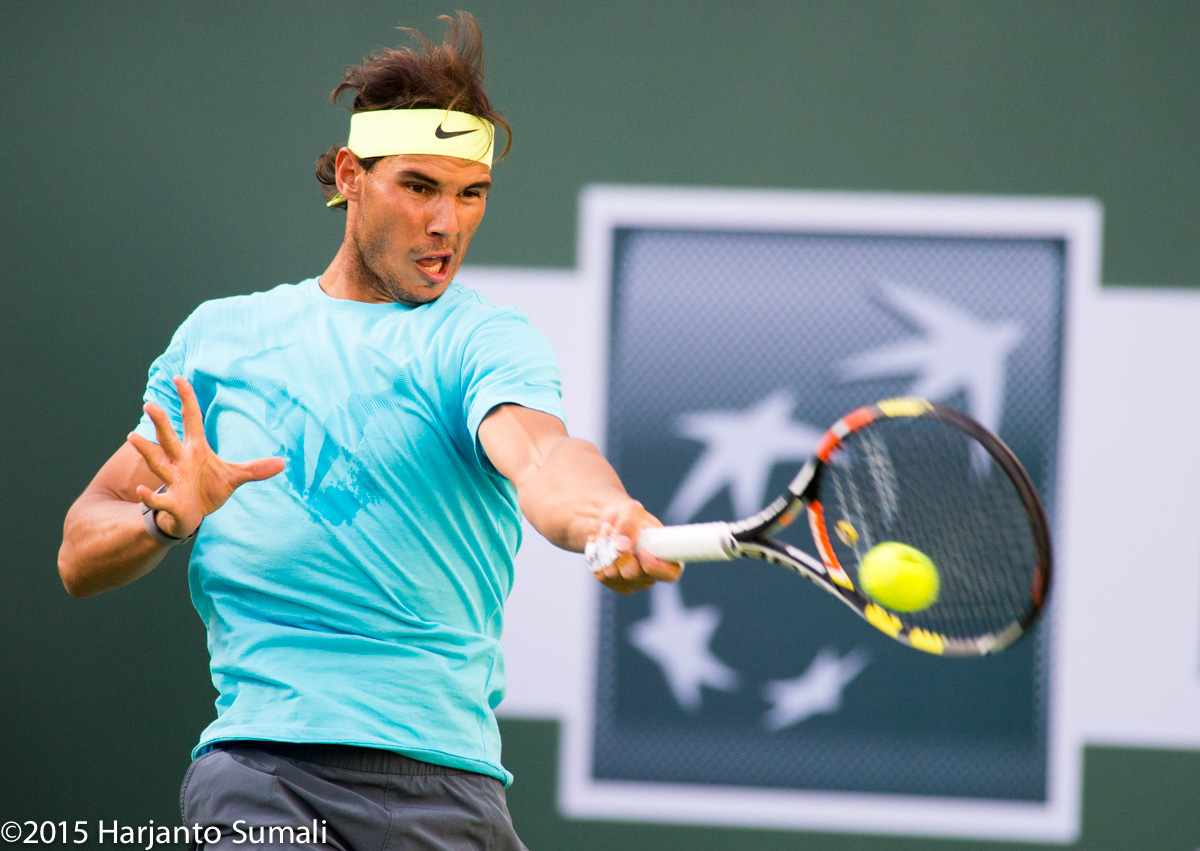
left=839, top=281, right=1024, bottom=439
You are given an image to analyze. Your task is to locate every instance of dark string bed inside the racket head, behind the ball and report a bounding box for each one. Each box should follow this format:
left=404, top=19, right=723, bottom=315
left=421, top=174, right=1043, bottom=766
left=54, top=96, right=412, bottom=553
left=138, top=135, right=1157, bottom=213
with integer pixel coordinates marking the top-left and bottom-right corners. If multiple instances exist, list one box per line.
left=821, top=416, right=1039, bottom=637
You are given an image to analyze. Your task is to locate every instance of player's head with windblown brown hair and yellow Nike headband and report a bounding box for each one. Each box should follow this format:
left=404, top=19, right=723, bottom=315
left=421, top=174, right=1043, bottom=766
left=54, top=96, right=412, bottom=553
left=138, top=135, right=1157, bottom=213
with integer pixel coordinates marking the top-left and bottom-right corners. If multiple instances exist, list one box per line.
left=317, top=12, right=511, bottom=304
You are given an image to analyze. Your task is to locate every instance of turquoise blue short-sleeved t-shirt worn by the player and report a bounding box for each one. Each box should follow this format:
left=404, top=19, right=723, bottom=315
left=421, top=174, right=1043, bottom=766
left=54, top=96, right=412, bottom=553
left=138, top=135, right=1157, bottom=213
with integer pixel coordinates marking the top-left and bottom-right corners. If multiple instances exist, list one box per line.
left=138, top=278, right=563, bottom=784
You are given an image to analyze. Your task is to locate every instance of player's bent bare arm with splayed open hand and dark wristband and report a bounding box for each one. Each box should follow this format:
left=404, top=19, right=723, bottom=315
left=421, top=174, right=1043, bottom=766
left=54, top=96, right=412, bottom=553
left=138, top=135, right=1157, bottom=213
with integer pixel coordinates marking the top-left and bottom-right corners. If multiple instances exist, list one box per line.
left=59, top=376, right=283, bottom=597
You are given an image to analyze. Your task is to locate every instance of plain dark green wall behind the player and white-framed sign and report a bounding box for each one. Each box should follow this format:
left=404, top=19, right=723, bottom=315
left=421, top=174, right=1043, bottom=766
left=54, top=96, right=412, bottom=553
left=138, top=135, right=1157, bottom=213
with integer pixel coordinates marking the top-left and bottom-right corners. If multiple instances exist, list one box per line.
left=0, top=0, right=1200, bottom=851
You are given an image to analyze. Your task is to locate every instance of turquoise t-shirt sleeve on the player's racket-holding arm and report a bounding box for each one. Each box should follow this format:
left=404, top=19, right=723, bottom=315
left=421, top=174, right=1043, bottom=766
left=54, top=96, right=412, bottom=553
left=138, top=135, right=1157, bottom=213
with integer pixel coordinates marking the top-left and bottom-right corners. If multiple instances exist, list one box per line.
left=462, top=307, right=566, bottom=466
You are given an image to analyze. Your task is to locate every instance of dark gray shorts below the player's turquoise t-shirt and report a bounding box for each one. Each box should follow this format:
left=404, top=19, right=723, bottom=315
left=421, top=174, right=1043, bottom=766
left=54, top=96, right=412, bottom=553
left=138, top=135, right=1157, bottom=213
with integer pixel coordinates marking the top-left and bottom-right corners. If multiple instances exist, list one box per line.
left=180, top=742, right=527, bottom=851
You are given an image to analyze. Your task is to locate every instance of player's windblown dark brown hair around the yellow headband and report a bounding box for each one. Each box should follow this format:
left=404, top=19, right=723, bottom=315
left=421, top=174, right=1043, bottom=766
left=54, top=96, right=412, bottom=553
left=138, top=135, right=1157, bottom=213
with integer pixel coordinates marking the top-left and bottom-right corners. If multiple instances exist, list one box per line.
left=317, top=12, right=512, bottom=209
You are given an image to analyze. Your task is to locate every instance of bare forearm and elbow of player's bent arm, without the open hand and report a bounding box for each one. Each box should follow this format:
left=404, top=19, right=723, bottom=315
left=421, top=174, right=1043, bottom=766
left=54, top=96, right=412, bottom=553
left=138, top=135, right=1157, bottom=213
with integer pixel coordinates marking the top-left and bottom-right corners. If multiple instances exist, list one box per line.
left=59, top=443, right=168, bottom=597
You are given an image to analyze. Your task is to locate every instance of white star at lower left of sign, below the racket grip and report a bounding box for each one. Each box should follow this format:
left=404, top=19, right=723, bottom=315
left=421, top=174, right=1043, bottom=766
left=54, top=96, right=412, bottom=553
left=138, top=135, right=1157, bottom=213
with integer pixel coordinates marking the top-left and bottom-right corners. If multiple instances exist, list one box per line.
left=629, top=582, right=738, bottom=712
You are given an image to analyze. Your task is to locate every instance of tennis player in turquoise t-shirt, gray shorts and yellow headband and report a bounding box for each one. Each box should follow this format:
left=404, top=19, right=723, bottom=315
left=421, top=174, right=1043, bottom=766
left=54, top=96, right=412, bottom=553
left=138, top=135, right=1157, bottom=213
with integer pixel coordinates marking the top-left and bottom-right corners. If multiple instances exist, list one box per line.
left=59, top=13, right=679, bottom=851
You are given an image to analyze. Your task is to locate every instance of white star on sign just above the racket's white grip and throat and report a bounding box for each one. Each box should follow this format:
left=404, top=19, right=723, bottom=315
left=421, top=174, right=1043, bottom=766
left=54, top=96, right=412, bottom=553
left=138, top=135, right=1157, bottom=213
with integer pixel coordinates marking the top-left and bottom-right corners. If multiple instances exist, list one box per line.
left=664, top=389, right=822, bottom=523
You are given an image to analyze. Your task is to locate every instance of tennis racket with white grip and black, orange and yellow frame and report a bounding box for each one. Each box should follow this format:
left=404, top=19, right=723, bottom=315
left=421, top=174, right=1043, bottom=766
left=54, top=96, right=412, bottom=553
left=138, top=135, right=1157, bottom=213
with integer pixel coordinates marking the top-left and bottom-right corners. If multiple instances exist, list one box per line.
left=586, top=397, right=1051, bottom=657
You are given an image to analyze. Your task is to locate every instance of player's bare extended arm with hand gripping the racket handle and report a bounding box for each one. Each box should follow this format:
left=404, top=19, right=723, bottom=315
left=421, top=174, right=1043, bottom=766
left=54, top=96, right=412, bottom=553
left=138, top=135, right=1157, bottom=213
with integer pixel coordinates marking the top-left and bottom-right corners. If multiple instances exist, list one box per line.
left=479, top=404, right=679, bottom=593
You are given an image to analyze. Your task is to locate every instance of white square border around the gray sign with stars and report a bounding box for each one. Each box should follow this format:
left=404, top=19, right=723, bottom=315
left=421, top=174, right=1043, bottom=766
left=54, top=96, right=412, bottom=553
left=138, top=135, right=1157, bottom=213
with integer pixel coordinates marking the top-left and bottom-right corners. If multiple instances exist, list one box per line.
left=559, top=186, right=1102, bottom=843
